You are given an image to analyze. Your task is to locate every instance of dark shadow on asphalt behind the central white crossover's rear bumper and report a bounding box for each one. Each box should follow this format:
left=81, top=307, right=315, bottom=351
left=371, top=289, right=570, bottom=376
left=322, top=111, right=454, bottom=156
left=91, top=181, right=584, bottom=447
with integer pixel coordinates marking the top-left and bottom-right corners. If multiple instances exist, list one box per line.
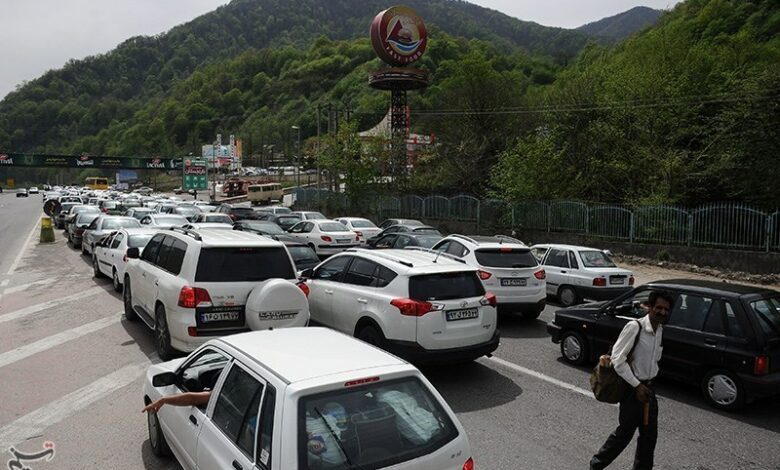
left=421, top=362, right=523, bottom=413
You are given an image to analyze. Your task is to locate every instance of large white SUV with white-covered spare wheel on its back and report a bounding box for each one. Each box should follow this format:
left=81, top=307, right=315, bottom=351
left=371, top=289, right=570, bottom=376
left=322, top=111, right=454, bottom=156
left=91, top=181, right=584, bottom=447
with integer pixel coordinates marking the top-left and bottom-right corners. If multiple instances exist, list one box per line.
left=122, top=228, right=309, bottom=360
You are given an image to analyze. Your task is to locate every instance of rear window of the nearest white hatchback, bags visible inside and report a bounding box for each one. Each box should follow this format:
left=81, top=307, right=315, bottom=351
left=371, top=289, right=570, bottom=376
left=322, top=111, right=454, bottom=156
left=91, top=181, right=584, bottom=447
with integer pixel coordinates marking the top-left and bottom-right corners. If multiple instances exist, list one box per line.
left=298, top=377, right=458, bottom=470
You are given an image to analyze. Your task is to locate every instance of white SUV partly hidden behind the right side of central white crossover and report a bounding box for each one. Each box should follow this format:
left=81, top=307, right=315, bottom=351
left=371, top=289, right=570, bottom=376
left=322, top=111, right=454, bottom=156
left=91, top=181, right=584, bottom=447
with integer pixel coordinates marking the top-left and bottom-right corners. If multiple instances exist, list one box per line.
left=433, top=235, right=547, bottom=319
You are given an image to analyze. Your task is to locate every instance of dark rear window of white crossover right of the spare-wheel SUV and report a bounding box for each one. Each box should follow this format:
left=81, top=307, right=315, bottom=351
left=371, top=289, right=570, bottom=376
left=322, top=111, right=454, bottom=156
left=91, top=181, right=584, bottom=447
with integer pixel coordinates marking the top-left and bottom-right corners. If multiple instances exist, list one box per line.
left=409, top=271, right=485, bottom=301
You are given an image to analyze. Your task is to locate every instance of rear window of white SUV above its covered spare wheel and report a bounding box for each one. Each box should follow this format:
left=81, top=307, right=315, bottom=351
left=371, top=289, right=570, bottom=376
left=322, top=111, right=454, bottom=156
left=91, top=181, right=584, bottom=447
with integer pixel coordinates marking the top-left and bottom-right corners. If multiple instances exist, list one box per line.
left=195, top=246, right=295, bottom=282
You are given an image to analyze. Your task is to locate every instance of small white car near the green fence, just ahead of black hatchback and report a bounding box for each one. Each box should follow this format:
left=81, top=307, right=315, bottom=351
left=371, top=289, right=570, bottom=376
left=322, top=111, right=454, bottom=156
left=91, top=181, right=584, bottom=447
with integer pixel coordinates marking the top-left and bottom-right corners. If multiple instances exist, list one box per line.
left=531, top=244, right=634, bottom=307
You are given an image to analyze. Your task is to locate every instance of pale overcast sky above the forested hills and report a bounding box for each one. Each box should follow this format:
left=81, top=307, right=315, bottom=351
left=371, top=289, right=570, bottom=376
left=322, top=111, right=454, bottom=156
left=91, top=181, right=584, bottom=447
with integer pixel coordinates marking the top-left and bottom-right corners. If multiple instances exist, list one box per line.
left=0, top=0, right=679, bottom=97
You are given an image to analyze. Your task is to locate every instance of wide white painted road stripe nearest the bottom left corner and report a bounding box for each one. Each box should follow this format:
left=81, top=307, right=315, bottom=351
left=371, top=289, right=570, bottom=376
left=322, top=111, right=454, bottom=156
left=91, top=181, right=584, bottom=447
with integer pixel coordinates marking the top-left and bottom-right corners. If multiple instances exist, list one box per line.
left=0, top=362, right=149, bottom=449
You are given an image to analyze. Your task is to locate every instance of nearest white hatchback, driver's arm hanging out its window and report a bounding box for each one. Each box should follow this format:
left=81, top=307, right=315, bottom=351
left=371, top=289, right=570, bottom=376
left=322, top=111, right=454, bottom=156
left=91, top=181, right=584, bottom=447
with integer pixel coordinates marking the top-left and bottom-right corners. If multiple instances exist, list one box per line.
left=144, top=328, right=474, bottom=470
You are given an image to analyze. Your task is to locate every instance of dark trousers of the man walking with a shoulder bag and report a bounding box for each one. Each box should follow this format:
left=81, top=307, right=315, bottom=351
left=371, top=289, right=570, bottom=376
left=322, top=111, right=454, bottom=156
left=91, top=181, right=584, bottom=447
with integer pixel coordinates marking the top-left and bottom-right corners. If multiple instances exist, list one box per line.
left=590, top=389, right=658, bottom=470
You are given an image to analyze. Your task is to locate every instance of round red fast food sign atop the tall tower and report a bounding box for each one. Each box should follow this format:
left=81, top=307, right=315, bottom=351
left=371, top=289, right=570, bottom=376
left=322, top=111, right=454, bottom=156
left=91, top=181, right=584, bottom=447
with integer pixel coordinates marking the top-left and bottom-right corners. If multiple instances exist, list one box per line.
left=371, top=6, right=428, bottom=66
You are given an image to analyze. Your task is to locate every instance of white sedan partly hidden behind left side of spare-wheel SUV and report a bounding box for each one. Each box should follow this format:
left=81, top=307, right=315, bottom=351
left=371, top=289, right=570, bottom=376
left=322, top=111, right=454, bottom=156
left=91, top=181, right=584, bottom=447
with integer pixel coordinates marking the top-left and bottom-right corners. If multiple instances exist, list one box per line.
left=92, top=228, right=157, bottom=292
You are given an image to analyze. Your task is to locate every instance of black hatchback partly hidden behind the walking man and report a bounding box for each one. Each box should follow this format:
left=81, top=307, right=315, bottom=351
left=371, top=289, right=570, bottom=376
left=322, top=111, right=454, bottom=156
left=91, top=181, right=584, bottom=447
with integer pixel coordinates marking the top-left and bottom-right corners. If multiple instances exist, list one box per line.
left=547, top=279, right=780, bottom=410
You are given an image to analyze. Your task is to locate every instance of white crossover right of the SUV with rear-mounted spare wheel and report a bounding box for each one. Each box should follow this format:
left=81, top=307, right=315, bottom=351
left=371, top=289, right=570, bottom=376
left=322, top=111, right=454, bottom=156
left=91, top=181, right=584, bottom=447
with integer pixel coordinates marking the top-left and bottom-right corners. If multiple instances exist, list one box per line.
left=303, top=249, right=499, bottom=363
